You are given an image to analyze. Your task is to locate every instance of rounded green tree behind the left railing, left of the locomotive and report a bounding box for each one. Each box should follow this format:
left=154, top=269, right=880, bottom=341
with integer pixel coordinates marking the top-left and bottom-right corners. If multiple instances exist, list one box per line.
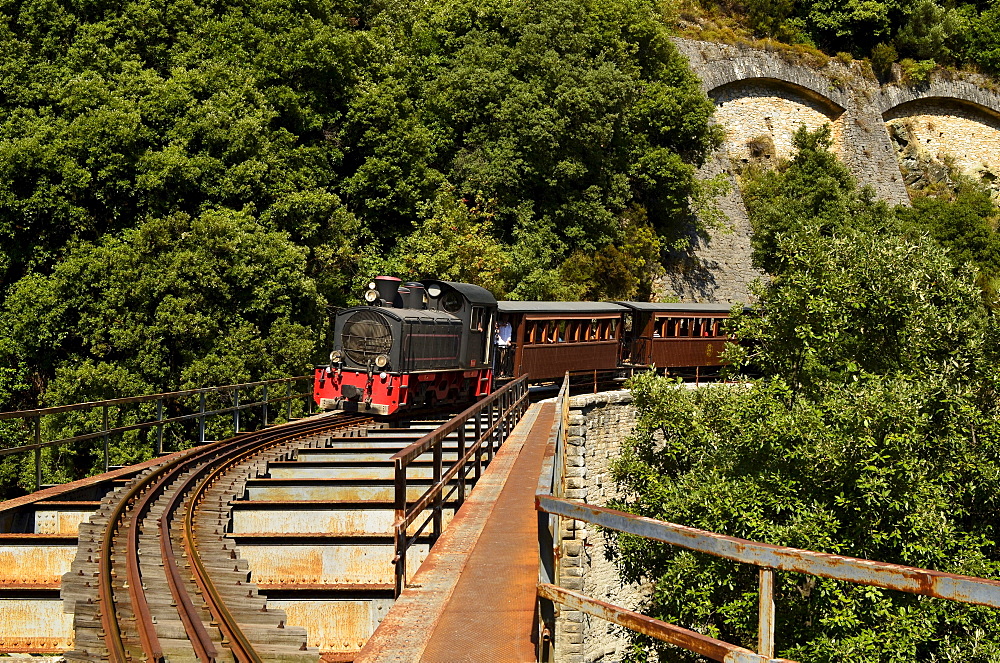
left=0, top=210, right=325, bottom=484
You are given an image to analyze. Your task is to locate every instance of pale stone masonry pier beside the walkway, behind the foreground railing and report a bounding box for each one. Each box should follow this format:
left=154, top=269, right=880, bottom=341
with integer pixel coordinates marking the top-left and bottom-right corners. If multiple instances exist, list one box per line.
left=555, top=391, right=645, bottom=663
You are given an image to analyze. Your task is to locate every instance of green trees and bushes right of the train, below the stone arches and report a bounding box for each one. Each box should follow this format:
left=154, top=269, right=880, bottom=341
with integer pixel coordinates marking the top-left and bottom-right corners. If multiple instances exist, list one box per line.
left=616, top=131, right=1000, bottom=663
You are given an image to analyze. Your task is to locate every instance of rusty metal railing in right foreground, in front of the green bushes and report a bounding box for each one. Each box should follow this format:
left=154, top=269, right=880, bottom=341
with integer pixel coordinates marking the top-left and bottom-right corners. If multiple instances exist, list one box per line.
left=535, top=376, right=1000, bottom=663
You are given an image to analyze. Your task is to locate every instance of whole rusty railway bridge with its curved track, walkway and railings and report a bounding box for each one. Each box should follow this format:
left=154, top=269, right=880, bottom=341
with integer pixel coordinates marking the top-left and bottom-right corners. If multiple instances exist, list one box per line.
left=0, top=377, right=1000, bottom=663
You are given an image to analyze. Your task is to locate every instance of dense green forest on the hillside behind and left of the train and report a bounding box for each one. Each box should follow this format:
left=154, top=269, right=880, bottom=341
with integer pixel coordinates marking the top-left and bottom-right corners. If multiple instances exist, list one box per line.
left=0, top=0, right=717, bottom=492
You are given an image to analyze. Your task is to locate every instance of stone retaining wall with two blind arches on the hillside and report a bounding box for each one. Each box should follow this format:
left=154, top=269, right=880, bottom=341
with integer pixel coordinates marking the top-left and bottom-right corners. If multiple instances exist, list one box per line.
left=654, top=38, right=1000, bottom=303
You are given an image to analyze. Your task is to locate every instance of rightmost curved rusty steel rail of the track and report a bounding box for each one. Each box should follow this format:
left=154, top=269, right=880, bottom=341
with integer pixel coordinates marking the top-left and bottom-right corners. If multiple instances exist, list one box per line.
left=182, top=415, right=371, bottom=663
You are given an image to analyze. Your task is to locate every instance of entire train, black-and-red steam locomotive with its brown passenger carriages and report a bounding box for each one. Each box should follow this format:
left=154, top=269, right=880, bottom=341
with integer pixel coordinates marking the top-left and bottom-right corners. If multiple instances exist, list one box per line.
left=314, top=276, right=729, bottom=415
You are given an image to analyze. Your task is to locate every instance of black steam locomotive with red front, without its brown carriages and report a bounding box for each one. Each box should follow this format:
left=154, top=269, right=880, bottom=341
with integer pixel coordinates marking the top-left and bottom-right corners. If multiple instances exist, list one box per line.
left=314, top=276, right=497, bottom=415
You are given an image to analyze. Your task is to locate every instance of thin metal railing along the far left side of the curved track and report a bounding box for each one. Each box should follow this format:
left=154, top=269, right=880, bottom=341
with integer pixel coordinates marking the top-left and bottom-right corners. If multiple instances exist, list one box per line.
left=0, top=375, right=313, bottom=490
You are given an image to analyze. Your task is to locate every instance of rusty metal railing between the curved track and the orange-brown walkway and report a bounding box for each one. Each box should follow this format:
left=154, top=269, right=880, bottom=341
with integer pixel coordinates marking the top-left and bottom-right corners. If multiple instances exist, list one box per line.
left=392, top=375, right=528, bottom=596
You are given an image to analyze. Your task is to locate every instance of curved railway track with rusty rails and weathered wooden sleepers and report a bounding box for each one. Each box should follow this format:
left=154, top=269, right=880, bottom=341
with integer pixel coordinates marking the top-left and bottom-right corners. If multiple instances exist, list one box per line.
left=64, top=415, right=370, bottom=663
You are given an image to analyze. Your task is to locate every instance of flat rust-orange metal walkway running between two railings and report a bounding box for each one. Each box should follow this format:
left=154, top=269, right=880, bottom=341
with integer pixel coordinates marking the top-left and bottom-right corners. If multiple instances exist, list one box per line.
left=355, top=403, right=555, bottom=663
